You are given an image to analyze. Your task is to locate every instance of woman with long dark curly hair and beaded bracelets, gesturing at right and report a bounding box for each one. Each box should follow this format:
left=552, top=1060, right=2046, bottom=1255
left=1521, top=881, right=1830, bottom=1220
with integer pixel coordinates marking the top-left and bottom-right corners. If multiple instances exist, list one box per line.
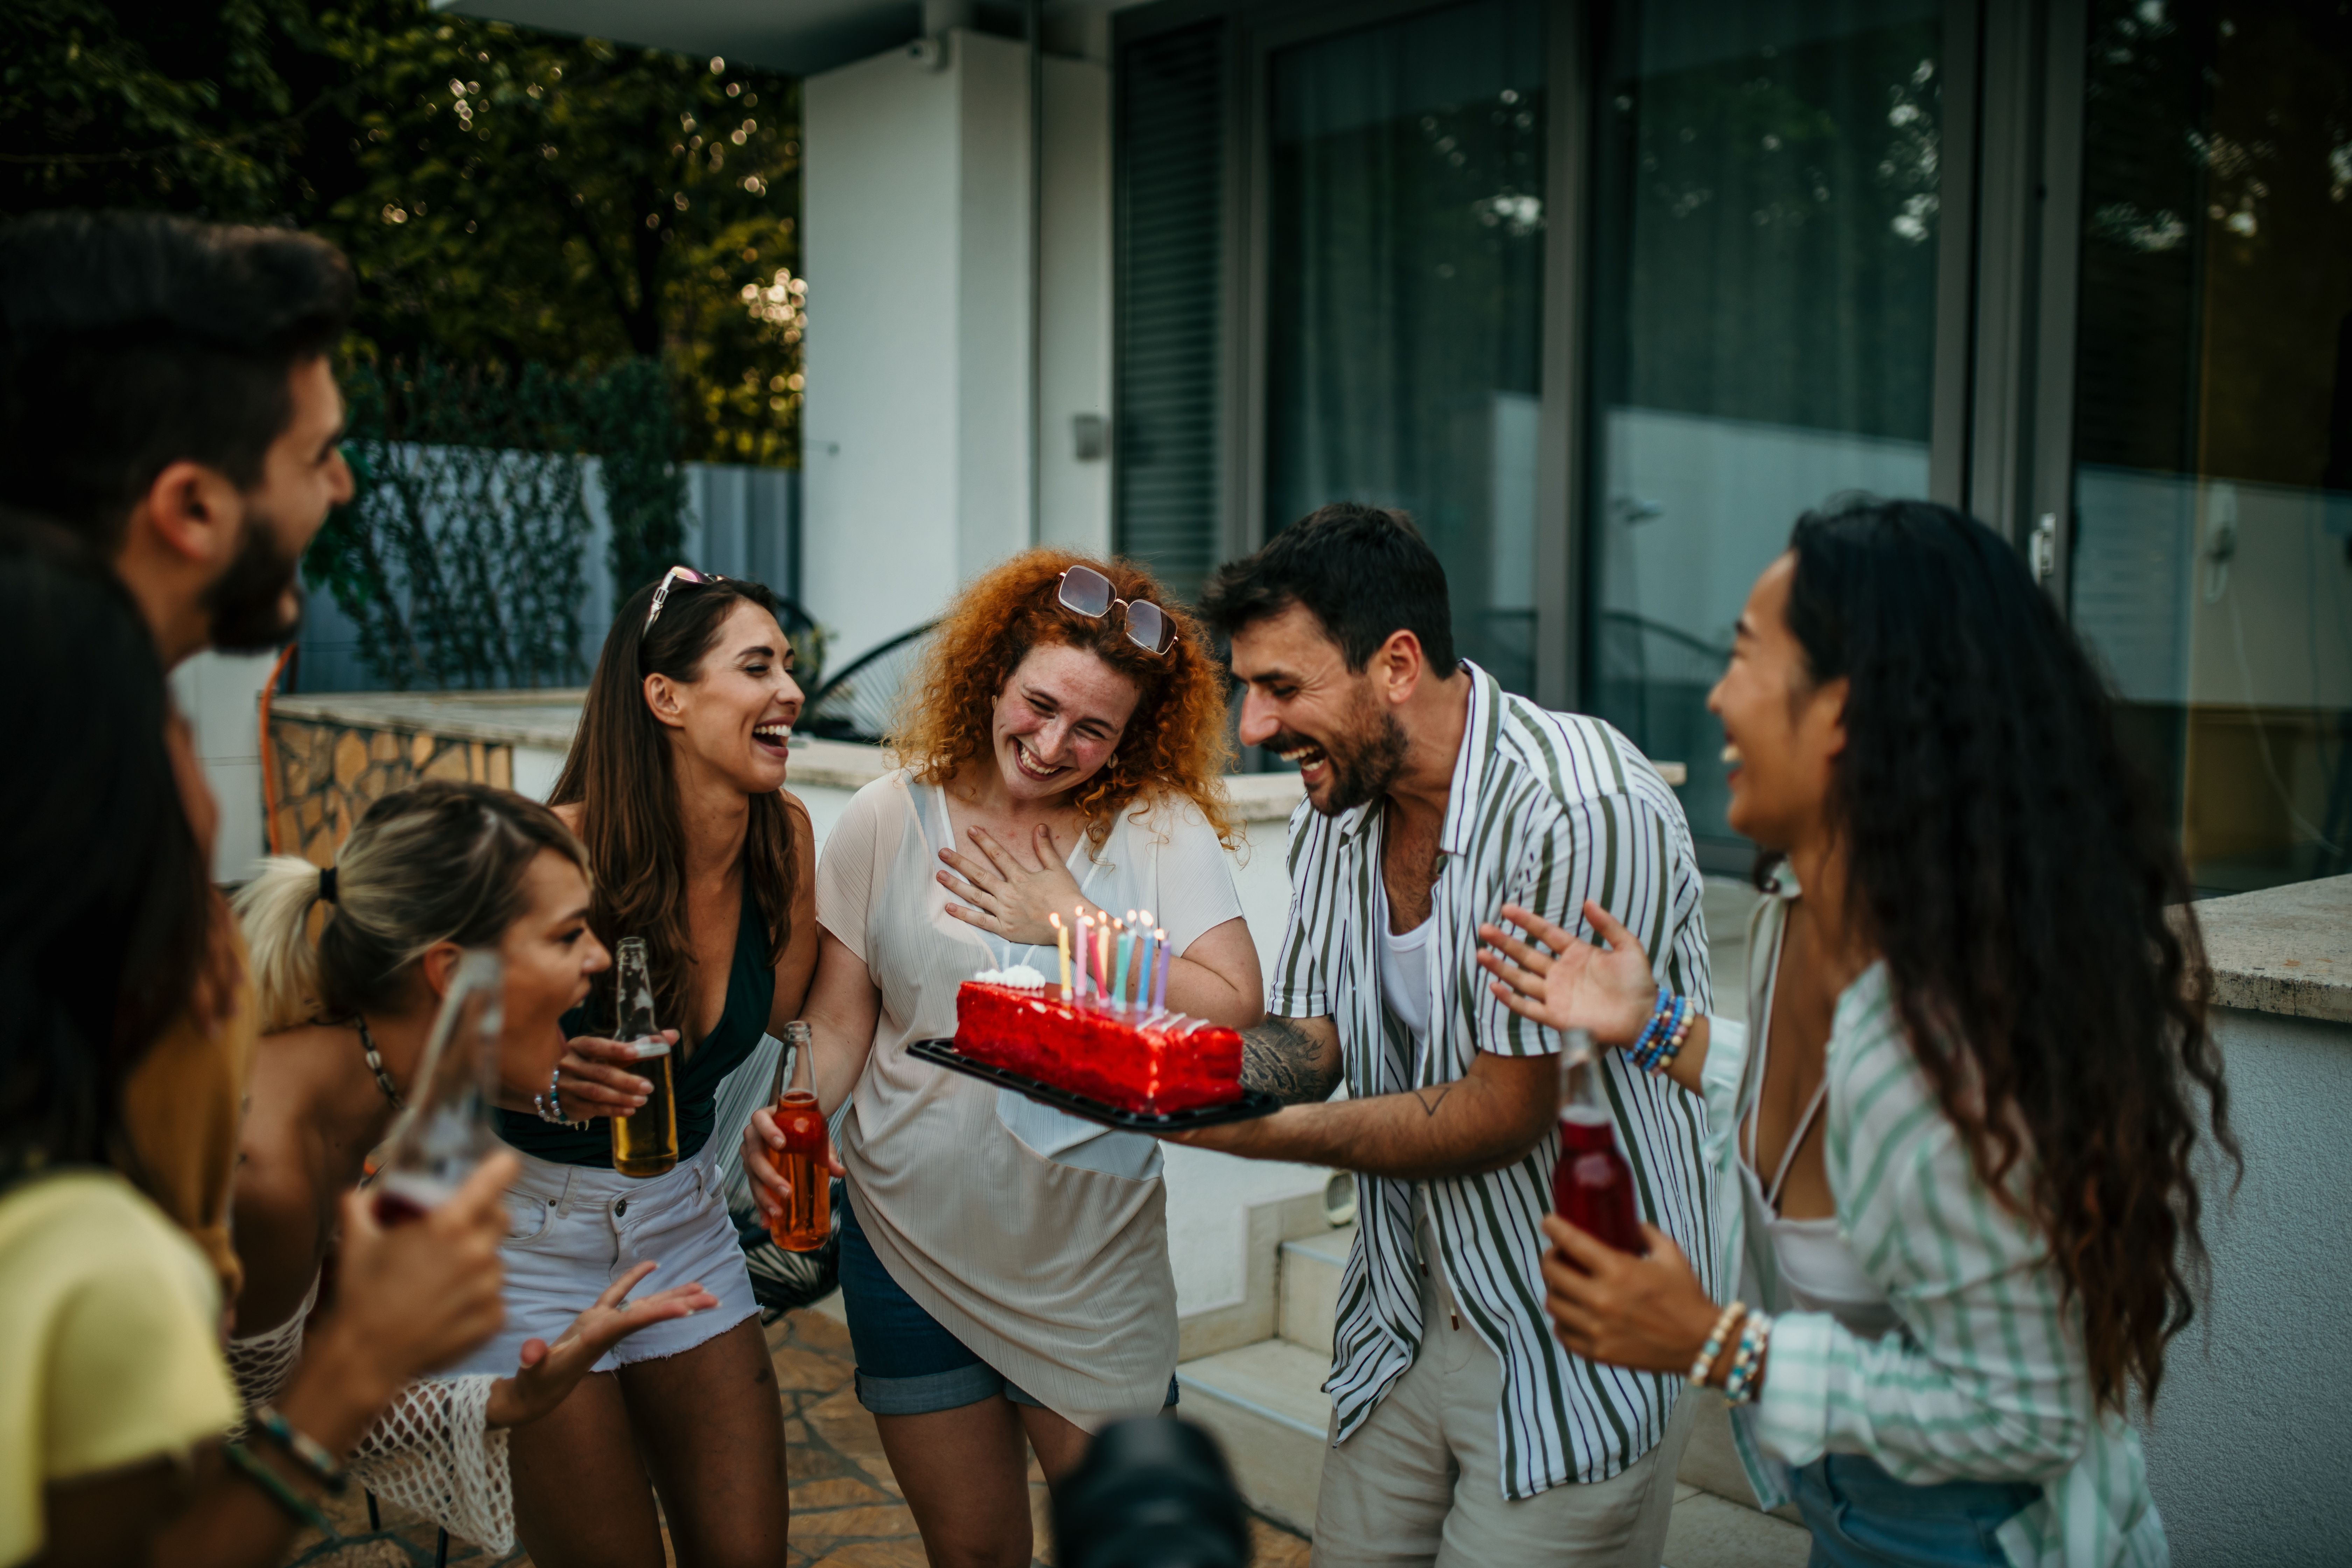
left=1484, top=498, right=2237, bottom=1568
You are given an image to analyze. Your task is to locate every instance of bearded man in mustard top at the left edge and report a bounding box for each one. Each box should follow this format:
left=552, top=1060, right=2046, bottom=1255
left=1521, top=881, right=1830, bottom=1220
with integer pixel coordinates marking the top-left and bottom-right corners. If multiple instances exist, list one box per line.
left=0, top=211, right=353, bottom=1300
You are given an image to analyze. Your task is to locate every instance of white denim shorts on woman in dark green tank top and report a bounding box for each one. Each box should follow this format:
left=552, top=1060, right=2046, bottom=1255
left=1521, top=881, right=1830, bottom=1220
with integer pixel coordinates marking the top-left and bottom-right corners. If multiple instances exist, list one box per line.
left=451, top=1138, right=760, bottom=1378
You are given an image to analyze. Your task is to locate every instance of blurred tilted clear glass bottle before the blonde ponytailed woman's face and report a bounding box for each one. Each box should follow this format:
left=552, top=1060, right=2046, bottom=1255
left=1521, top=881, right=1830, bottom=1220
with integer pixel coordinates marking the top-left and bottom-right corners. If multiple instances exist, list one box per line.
left=374, top=950, right=506, bottom=1225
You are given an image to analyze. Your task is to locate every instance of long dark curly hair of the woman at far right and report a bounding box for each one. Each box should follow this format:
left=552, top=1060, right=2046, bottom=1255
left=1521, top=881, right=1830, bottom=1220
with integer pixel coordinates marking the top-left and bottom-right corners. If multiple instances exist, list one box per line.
left=1787, top=498, right=2237, bottom=1413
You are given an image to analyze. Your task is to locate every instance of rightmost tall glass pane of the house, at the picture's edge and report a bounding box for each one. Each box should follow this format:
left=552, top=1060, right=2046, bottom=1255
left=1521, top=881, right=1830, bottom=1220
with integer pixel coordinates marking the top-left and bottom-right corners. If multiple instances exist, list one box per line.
left=2070, top=0, right=2352, bottom=891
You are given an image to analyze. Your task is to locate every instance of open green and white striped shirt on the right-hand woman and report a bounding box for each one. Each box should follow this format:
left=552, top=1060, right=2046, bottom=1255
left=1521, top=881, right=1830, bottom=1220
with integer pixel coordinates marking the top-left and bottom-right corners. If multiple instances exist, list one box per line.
left=1705, top=879, right=2169, bottom=1568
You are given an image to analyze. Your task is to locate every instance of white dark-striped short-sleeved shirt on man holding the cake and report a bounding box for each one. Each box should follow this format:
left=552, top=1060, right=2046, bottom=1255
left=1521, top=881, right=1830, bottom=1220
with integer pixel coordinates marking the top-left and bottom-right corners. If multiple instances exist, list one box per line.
left=1265, top=660, right=1717, bottom=1500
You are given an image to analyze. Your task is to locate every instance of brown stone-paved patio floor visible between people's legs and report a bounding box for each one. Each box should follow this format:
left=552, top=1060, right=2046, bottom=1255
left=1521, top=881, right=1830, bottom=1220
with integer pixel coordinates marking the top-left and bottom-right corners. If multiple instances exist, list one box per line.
left=287, top=1312, right=1308, bottom=1568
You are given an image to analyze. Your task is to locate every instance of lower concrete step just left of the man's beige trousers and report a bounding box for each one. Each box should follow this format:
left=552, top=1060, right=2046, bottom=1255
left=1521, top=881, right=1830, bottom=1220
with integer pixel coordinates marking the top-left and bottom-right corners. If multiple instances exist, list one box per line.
left=1176, top=1319, right=1331, bottom=1531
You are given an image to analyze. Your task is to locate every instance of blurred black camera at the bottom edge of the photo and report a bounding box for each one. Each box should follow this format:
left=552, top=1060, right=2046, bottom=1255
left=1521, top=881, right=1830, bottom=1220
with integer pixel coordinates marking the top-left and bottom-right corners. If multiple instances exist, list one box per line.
left=1054, top=1418, right=1249, bottom=1568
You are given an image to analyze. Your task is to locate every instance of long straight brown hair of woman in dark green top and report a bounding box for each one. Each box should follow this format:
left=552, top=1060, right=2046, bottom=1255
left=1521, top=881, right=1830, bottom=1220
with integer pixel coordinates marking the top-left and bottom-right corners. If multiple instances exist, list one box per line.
left=548, top=578, right=793, bottom=1025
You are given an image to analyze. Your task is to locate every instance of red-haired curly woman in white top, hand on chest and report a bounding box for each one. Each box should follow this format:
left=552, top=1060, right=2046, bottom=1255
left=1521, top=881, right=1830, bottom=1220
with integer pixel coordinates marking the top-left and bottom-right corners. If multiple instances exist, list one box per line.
left=746, top=550, right=1261, bottom=1563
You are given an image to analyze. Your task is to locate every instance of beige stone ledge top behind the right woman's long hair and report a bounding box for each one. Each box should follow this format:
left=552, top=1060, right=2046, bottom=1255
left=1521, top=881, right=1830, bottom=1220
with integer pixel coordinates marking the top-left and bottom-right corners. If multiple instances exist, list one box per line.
left=2197, top=877, right=2352, bottom=1023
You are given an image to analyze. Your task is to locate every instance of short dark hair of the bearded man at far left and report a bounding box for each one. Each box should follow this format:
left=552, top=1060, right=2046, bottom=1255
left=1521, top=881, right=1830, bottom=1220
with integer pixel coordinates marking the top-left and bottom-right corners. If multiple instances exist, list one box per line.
left=0, top=211, right=353, bottom=552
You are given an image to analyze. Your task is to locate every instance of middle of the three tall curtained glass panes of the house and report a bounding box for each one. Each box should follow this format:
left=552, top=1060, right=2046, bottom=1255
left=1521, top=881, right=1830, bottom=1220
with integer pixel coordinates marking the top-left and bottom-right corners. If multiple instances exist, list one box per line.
left=1585, top=0, right=1943, bottom=844
